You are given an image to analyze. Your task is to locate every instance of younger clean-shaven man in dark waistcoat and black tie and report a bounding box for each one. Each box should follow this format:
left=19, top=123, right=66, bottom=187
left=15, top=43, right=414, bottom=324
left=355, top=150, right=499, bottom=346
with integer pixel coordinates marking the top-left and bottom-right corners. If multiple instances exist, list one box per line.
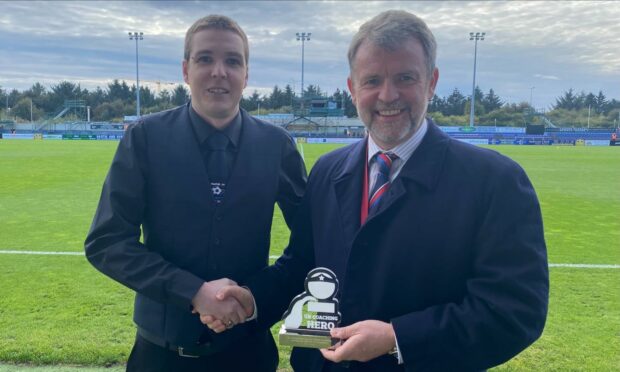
left=85, top=16, right=306, bottom=371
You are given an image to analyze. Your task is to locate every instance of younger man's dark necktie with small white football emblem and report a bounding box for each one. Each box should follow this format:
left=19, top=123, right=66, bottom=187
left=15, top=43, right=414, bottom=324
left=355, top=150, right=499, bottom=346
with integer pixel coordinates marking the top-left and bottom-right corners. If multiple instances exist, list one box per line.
left=207, top=131, right=229, bottom=203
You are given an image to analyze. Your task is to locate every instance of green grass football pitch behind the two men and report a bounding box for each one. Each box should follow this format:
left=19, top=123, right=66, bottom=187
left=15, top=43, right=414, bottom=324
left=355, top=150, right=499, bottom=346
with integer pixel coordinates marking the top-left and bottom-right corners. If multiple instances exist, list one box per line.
left=0, top=140, right=620, bottom=371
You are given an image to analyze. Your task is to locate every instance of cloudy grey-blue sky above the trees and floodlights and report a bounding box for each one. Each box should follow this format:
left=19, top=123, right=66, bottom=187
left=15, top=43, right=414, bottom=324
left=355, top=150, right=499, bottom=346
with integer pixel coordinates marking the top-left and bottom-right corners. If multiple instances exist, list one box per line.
left=0, top=0, right=620, bottom=109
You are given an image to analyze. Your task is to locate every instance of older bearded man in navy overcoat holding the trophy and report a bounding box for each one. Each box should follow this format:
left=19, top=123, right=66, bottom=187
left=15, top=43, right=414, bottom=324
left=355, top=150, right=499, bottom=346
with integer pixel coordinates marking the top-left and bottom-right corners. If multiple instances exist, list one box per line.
left=208, top=11, right=548, bottom=371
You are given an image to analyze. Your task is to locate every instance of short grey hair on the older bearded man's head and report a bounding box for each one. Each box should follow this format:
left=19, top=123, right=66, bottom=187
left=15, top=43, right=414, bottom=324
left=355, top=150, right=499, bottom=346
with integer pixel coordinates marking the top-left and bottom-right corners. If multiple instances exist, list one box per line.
left=347, top=10, right=437, bottom=77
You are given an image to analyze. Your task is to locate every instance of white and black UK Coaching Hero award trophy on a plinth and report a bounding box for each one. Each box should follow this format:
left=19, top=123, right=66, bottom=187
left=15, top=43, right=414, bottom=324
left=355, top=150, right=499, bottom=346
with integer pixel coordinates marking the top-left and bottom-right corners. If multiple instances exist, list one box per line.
left=279, top=267, right=340, bottom=348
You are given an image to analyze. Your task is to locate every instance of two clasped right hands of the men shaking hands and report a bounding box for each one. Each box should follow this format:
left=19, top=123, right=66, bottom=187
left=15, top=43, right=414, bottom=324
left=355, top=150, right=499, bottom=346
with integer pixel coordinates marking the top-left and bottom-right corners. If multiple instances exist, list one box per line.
left=192, top=278, right=255, bottom=333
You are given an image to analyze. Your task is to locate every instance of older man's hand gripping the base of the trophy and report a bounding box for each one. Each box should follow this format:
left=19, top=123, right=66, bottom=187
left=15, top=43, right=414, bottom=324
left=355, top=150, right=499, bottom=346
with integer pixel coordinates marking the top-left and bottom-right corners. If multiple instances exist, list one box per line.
left=321, top=320, right=396, bottom=363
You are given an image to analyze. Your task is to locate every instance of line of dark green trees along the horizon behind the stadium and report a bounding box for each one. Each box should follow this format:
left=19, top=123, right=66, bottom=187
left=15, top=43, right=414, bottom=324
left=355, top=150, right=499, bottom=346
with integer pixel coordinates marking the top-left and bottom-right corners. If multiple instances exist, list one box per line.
left=0, top=80, right=620, bottom=127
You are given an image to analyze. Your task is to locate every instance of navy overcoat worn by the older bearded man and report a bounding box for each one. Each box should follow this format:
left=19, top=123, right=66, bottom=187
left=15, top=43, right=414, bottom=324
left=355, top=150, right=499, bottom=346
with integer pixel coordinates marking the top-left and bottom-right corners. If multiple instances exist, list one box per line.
left=250, top=122, right=548, bottom=371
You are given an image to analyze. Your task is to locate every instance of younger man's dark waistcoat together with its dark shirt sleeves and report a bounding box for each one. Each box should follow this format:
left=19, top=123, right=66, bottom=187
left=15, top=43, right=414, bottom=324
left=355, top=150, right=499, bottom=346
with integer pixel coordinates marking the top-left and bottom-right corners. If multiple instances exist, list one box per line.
left=85, top=104, right=306, bottom=366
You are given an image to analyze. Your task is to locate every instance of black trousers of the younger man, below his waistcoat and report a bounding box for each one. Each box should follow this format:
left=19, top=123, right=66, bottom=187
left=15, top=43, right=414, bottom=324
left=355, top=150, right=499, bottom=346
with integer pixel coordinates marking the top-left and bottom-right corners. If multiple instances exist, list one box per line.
left=127, top=335, right=278, bottom=372
